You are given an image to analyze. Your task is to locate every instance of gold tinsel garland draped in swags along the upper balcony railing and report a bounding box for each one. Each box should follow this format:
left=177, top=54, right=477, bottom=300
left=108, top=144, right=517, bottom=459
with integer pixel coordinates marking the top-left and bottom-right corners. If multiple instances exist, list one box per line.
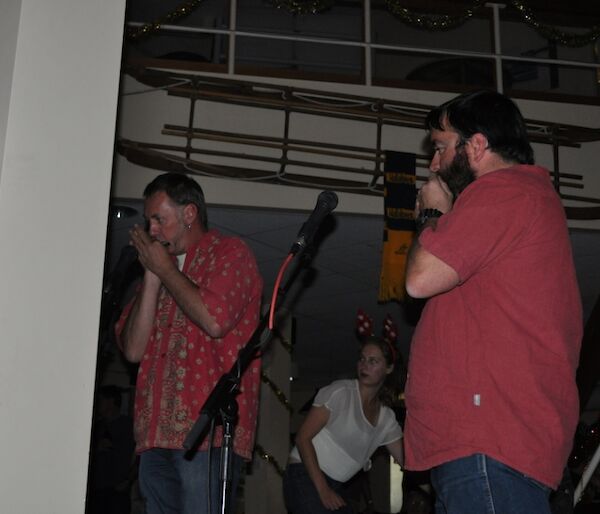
left=127, top=0, right=600, bottom=47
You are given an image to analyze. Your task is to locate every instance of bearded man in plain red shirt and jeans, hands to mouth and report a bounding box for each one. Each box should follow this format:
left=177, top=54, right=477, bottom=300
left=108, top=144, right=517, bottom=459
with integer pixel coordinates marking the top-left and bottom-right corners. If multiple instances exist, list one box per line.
left=404, top=91, right=583, bottom=514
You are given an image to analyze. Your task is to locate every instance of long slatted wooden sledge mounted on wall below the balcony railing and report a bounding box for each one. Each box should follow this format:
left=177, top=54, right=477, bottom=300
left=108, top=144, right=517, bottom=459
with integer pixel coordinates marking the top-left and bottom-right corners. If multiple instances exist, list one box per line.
left=117, top=68, right=600, bottom=219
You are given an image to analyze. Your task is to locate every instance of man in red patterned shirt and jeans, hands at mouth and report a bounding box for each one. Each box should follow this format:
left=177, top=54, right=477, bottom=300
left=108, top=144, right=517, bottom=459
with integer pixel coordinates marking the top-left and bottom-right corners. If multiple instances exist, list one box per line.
left=117, top=173, right=262, bottom=514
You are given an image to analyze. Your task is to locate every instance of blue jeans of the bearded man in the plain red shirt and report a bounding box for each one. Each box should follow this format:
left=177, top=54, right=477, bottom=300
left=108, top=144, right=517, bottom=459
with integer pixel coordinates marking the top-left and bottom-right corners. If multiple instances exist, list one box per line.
left=431, top=453, right=550, bottom=514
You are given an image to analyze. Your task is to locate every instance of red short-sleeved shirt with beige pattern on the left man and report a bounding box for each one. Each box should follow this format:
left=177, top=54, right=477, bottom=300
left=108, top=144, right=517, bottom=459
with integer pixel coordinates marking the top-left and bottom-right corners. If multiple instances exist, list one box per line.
left=117, top=230, right=262, bottom=459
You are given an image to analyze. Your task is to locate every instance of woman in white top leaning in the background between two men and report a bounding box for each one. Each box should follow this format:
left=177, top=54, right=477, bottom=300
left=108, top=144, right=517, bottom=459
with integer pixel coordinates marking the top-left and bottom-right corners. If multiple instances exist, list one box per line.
left=283, top=337, right=403, bottom=514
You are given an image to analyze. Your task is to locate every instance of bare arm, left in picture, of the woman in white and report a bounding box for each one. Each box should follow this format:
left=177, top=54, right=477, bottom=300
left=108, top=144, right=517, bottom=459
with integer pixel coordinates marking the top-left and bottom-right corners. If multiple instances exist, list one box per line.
left=296, top=406, right=346, bottom=510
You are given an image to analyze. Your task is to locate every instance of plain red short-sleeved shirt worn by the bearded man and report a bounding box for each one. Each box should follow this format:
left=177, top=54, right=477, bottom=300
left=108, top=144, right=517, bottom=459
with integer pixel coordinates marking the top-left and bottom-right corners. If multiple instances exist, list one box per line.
left=405, top=165, right=583, bottom=488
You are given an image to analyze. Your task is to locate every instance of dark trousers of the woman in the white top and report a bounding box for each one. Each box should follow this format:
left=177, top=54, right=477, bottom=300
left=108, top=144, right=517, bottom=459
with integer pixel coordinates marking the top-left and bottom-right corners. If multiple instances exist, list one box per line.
left=283, top=463, right=353, bottom=514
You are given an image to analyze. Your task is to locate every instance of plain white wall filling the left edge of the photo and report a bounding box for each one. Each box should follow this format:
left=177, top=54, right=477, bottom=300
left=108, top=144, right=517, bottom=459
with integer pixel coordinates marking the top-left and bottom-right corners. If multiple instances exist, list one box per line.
left=0, top=0, right=125, bottom=514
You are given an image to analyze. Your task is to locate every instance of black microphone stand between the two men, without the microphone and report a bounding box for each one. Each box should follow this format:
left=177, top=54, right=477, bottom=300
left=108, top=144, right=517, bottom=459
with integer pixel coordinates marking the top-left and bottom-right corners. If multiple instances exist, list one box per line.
left=183, top=240, right=312, bottom=514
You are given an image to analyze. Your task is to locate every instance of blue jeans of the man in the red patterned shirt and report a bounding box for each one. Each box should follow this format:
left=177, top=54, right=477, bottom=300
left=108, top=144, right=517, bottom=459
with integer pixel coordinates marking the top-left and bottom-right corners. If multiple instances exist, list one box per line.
left=139, top=448, right=242, bottom=514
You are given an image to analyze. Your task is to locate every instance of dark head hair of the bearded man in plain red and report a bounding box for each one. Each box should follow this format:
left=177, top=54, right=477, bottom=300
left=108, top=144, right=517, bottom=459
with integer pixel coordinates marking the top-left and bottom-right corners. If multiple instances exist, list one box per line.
left=425, top=90, right=534, bottom=164
